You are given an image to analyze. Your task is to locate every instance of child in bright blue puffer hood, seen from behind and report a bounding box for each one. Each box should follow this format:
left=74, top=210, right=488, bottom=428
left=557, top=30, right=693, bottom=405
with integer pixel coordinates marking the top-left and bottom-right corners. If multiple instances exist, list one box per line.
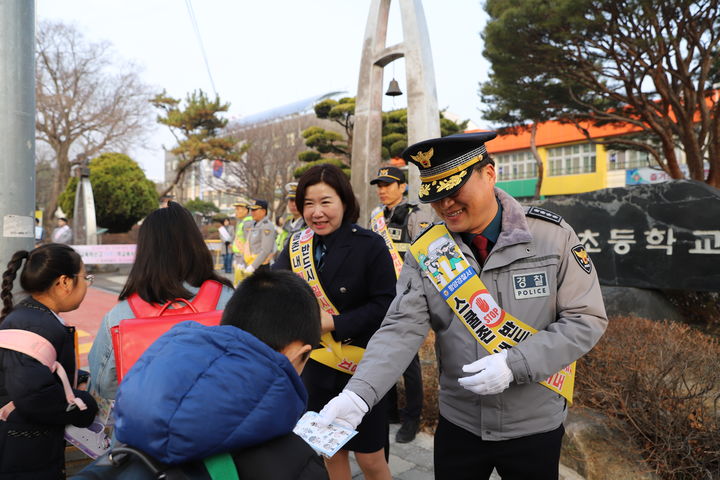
left=74, top=271, right=328, bottom=480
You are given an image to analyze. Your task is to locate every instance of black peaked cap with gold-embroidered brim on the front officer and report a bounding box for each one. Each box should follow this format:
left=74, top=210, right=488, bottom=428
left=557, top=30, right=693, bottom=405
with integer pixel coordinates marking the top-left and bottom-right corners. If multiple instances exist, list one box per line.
left=402, top=132, right=497, bottom=203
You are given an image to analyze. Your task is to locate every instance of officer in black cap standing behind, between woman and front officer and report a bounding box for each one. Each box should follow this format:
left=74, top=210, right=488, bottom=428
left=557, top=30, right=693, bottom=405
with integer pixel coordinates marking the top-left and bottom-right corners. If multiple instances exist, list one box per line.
left=370, top=166, right=432, bottom=443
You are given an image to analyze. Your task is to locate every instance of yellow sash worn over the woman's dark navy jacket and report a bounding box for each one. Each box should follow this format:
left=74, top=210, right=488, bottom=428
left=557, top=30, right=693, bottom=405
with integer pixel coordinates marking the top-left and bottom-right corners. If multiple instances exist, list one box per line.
left=290, top=228, right=365, bottom=375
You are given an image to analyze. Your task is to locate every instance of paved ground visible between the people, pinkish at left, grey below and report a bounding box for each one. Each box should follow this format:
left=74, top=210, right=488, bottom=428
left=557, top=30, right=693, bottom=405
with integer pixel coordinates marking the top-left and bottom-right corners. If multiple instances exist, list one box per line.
left=67, top=266, right=583, bottom=480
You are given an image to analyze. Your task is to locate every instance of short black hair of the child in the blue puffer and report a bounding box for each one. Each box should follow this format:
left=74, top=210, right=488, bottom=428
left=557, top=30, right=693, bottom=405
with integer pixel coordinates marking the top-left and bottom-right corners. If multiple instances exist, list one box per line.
left=221, top=270, right=320, bottom=351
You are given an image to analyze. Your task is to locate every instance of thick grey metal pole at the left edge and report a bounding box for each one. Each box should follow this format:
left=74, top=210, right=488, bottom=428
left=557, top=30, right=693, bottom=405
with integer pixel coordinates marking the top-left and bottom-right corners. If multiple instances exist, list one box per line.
left=0, top=0, right=35, bottom=271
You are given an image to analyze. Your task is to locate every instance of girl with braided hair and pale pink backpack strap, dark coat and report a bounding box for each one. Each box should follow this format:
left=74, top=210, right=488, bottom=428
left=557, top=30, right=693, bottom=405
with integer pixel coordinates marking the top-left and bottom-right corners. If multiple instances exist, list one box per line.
left=0, top=243, right=97, bottom=480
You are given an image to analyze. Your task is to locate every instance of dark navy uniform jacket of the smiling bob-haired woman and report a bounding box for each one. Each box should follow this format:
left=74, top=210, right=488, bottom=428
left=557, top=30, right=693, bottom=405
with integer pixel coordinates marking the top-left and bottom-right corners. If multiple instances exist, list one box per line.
left=273, top=222, right=395, bottom=395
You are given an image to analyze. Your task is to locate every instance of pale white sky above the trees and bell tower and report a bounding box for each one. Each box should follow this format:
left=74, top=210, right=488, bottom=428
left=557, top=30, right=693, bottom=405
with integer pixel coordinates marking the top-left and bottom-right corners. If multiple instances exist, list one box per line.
left=36, top=0, right=487, bottom=180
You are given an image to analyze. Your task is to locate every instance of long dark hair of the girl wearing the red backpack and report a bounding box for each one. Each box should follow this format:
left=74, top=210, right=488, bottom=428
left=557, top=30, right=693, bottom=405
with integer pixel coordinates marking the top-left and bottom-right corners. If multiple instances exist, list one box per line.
left=120, top=202, right=232, bottom=303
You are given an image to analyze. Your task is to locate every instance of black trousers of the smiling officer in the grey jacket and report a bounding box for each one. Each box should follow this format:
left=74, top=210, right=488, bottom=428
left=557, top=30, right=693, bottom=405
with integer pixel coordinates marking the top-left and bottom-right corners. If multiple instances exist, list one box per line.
left=434, top=417, right=565, bottom=480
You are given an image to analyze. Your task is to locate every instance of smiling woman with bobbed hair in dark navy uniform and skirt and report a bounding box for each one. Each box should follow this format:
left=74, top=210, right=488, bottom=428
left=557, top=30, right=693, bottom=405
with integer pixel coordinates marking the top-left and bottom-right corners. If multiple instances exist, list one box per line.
left=273, top=165, right=396, bottom=480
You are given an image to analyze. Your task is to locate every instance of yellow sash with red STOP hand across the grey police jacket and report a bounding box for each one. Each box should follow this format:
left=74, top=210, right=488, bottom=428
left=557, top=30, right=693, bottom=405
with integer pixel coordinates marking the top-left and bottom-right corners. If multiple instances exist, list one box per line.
left=410, top=225, right=575, bottom=403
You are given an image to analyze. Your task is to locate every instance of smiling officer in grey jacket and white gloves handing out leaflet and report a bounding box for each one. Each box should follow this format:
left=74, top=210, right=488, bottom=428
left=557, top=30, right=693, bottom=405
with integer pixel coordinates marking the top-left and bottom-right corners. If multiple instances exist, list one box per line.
left=321, top=132, right=607, bottom=480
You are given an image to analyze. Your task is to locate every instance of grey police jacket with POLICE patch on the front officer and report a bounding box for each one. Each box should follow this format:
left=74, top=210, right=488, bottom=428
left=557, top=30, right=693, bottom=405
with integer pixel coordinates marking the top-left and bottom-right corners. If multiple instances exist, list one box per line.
left=348, top=189, right=607, bottom=440
